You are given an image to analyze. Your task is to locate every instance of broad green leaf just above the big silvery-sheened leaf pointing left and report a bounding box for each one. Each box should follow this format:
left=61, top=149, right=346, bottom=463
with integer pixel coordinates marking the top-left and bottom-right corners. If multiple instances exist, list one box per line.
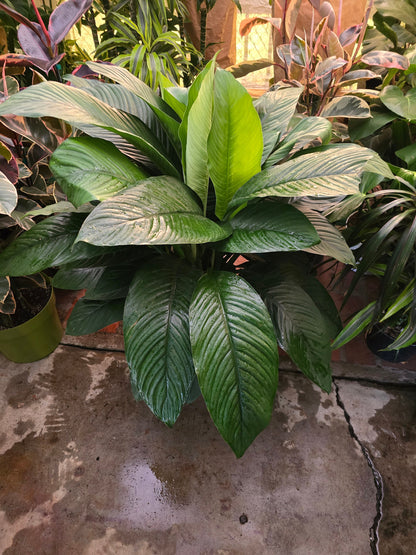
left=50, top=137, right=147, bottom=206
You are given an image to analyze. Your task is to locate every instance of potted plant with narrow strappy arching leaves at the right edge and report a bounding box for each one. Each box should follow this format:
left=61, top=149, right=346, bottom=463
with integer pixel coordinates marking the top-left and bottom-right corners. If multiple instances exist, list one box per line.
left=333, top=168, right=416, bottom=362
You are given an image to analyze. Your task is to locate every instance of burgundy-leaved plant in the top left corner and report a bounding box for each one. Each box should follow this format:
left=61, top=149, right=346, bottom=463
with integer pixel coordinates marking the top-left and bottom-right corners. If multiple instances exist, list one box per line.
left=0, top=0, right=92, bottom=76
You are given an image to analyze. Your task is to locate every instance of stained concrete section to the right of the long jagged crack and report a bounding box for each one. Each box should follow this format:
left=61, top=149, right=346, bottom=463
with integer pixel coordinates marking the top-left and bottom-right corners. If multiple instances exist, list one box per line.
left=339, top=382, right=416, bottom=555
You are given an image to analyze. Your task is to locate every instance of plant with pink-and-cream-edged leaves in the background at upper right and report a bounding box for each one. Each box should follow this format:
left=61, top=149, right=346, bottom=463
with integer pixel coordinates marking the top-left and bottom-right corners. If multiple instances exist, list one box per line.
left=240, top=0, right=409, bottom=117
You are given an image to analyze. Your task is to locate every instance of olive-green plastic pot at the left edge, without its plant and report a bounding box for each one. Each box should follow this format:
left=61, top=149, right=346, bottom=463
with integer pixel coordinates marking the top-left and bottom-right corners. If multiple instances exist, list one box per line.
left=0, top=290, right=64, bottom=362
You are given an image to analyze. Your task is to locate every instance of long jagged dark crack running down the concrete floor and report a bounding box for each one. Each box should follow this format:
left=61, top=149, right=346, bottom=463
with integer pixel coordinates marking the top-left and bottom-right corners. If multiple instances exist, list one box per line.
left=332, top=379, right=384, bottom=555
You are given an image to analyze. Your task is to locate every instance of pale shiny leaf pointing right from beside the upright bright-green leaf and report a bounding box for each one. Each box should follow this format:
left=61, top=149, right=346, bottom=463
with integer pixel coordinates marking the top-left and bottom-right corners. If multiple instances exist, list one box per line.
left=230, top=145, right=373, bottom=208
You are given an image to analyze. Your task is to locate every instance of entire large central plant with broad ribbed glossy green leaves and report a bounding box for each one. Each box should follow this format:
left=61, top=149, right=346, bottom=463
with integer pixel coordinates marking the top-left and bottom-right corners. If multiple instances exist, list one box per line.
left=0, top=62, right=384, bottom=456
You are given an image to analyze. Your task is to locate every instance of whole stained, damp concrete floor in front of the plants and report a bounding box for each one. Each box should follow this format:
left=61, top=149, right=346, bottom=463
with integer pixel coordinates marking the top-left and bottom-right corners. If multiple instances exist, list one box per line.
left=0, top=337, right=416, bottom=555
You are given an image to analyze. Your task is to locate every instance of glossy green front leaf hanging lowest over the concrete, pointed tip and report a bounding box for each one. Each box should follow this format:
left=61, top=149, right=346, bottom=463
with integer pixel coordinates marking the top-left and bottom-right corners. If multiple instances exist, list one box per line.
left=189, top=272, right=278, bottom=457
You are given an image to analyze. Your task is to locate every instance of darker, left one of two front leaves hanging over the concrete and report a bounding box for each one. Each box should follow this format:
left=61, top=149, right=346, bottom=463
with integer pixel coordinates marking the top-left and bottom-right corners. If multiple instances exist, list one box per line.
left=123, top=258, right=199, bottom=426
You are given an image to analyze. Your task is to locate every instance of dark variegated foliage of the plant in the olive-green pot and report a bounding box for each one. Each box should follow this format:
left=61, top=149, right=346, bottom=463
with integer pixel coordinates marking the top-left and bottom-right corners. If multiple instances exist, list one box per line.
left=0, top=72, right=70, bottom=327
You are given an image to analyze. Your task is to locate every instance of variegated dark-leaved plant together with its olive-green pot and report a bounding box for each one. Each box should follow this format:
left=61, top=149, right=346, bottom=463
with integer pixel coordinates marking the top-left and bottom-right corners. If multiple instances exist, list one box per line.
left=0, top=76, right=68, bottom=362
